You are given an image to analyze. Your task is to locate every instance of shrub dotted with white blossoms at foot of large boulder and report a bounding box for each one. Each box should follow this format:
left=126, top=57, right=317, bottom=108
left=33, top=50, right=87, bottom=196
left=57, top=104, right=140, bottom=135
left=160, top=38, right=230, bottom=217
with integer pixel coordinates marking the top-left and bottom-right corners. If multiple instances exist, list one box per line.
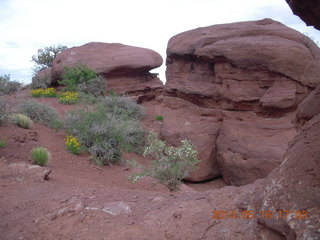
left=130, top=132, right=199, bottom=191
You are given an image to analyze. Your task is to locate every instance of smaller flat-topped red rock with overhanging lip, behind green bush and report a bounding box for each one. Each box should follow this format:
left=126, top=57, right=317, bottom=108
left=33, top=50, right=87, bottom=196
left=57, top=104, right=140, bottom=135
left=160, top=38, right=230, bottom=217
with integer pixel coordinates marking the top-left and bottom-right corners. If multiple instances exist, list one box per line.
left=51, top=42, right=163, bottom=95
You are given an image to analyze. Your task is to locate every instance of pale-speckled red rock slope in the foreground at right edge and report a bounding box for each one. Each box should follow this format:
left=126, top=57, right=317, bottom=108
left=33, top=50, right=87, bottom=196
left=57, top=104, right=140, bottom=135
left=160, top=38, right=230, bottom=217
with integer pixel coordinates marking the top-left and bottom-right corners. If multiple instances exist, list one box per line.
left=255, top=108, right=320, bottom=240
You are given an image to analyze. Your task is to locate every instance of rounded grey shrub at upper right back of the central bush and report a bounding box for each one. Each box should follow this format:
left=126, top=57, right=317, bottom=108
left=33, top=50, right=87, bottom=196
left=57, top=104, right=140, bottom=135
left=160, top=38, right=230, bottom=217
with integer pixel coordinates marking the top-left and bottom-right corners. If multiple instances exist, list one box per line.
left=100, top=95, right=143, bottom=120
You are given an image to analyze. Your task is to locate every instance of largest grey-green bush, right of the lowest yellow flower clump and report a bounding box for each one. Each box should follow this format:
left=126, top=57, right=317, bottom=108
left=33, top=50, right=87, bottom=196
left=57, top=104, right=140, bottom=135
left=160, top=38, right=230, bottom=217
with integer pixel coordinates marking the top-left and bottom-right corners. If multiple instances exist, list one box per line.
left=66, top=97, right=145, bottom=165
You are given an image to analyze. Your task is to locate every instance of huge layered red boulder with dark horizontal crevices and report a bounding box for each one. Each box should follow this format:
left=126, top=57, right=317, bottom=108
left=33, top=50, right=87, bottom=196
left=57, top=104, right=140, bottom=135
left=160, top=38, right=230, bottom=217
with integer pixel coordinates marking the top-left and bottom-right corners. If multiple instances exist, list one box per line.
left=162, top=19, right=320, bottom=185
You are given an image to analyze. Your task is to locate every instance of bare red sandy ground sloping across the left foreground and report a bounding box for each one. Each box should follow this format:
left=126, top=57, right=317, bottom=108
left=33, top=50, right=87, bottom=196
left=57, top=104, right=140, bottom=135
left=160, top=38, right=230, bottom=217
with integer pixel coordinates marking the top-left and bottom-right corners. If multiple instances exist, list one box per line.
left=0, top=90, right=225, bottom=239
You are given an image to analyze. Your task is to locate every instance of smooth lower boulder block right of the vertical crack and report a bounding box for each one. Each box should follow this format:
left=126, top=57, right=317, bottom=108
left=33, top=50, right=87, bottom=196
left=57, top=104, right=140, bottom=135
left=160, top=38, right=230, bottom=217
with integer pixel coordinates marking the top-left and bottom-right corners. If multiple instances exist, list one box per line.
left=216, top=113, right=296, bottom=186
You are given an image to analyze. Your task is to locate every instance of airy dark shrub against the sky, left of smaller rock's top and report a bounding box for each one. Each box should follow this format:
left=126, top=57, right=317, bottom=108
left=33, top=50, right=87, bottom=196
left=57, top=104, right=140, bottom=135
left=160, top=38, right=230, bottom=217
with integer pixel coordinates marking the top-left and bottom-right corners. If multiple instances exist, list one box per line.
left=32, top=45, right=68, bottom=73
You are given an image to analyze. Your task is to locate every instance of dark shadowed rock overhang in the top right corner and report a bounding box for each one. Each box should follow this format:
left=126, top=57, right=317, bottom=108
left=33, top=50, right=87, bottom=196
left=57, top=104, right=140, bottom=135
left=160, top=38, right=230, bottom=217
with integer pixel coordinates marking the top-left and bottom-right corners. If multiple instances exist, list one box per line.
left=286, top=0, right=320, bottom=30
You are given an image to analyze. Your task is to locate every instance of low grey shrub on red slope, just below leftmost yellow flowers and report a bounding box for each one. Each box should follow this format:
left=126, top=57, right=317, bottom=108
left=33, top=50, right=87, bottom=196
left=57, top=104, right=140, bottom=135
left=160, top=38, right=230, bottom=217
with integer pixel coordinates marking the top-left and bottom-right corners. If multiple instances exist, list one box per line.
left=19, top=100, right=62, bottom=129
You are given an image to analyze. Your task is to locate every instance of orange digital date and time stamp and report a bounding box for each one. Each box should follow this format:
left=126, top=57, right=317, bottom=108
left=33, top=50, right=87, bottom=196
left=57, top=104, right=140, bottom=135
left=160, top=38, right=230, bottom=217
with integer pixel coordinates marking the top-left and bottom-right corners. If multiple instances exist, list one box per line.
left=211, top=210, right=308, bottom=220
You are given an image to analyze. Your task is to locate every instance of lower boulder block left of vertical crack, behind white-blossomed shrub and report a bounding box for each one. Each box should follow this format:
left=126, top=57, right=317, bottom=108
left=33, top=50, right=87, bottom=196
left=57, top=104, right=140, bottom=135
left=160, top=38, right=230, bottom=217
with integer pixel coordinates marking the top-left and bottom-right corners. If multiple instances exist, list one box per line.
left=161, top=97, right=222, bottom=181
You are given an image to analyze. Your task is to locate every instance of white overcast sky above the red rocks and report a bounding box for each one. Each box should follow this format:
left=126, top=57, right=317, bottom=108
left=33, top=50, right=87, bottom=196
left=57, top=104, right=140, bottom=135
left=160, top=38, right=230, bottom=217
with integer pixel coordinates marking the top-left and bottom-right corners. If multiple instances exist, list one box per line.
left=0, top=0, right=320, bottom=83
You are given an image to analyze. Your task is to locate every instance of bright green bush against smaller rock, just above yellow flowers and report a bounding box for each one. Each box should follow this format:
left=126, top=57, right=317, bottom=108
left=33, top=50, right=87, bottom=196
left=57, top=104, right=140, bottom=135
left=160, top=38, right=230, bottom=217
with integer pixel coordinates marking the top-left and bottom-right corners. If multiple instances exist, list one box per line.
left=59, top=65, right=105, bottom=96
